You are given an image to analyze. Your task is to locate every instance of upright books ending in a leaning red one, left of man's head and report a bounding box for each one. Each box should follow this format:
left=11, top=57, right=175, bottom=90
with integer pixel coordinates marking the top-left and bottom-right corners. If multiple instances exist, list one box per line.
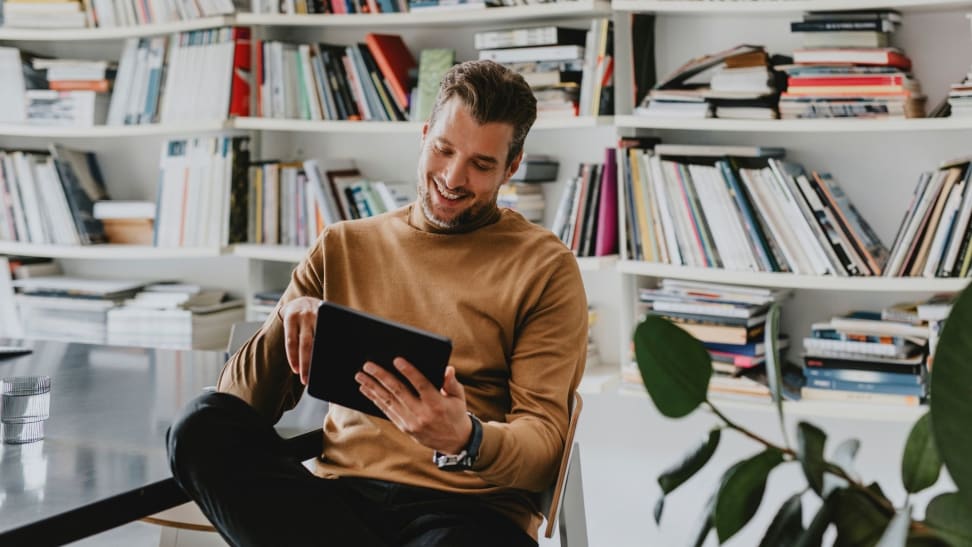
left=256, top=33, right=414, bottom=121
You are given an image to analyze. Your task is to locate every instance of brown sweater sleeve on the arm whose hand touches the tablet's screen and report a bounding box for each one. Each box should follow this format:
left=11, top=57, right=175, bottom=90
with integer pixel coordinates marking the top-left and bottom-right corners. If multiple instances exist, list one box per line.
left=216, top=230, right=327, bottom=423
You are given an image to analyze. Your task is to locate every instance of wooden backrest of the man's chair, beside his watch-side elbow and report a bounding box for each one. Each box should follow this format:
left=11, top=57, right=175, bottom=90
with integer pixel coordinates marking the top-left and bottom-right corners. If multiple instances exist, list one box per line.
left=540, top=393, right=587, bottom=547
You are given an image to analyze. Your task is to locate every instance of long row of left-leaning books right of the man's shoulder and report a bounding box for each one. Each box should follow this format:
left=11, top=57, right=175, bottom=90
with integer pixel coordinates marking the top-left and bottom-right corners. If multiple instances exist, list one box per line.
left=618, top=144, right=887, bottom=276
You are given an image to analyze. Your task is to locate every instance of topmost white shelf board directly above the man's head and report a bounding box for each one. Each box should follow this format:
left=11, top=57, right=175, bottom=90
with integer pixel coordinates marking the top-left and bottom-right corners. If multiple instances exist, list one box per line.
left=236, top=0, right=611, bottom=28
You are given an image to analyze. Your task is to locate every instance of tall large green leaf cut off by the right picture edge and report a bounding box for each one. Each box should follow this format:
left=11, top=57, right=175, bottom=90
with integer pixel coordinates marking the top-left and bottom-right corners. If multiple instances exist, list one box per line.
left=931, top=288, right=972, bottom=507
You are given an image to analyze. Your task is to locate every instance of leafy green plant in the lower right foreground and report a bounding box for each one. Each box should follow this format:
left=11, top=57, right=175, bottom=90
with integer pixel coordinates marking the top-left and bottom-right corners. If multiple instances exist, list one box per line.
left=634, top=289, right=972, bottom=547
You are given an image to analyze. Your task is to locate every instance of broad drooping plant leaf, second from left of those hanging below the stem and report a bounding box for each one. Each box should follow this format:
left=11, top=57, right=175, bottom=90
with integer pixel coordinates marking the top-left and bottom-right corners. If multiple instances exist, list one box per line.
left=715, top=448, right=783, bottom=543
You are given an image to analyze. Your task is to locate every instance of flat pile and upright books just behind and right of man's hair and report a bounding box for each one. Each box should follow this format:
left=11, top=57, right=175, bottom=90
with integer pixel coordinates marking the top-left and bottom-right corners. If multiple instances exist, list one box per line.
left=474, top=19, right=614, bottom=119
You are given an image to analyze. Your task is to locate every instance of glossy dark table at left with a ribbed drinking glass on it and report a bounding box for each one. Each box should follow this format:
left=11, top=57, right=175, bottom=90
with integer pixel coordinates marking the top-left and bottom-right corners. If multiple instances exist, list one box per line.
left=0, top=341, right=324, bottom=546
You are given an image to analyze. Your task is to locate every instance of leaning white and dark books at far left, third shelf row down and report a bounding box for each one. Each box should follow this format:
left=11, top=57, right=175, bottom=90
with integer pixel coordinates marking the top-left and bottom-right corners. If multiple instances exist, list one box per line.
left=0, top=144, right=107, bottom=245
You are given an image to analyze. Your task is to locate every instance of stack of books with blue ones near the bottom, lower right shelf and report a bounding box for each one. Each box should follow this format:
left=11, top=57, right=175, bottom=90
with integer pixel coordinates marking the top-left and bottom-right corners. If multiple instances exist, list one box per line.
left=803, top=311, right=929, bottom=406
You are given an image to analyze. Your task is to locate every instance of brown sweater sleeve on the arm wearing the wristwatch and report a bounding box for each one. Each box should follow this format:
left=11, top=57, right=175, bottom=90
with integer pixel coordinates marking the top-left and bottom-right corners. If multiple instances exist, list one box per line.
left=474, top=253, right=588, bottom=492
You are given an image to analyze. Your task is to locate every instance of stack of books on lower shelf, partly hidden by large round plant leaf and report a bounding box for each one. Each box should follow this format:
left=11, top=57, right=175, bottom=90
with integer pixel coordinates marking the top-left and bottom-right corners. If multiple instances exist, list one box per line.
left=628, top=279, right=802, bottom=400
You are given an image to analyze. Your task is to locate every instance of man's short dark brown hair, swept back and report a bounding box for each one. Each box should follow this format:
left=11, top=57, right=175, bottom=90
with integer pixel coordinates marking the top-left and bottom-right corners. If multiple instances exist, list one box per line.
left=429, top=61, right=537, bottom=167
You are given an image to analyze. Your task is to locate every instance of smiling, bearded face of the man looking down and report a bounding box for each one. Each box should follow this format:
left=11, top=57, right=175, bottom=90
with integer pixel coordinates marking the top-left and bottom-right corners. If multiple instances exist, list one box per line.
left=418, top=98, right=522, bottom=230
